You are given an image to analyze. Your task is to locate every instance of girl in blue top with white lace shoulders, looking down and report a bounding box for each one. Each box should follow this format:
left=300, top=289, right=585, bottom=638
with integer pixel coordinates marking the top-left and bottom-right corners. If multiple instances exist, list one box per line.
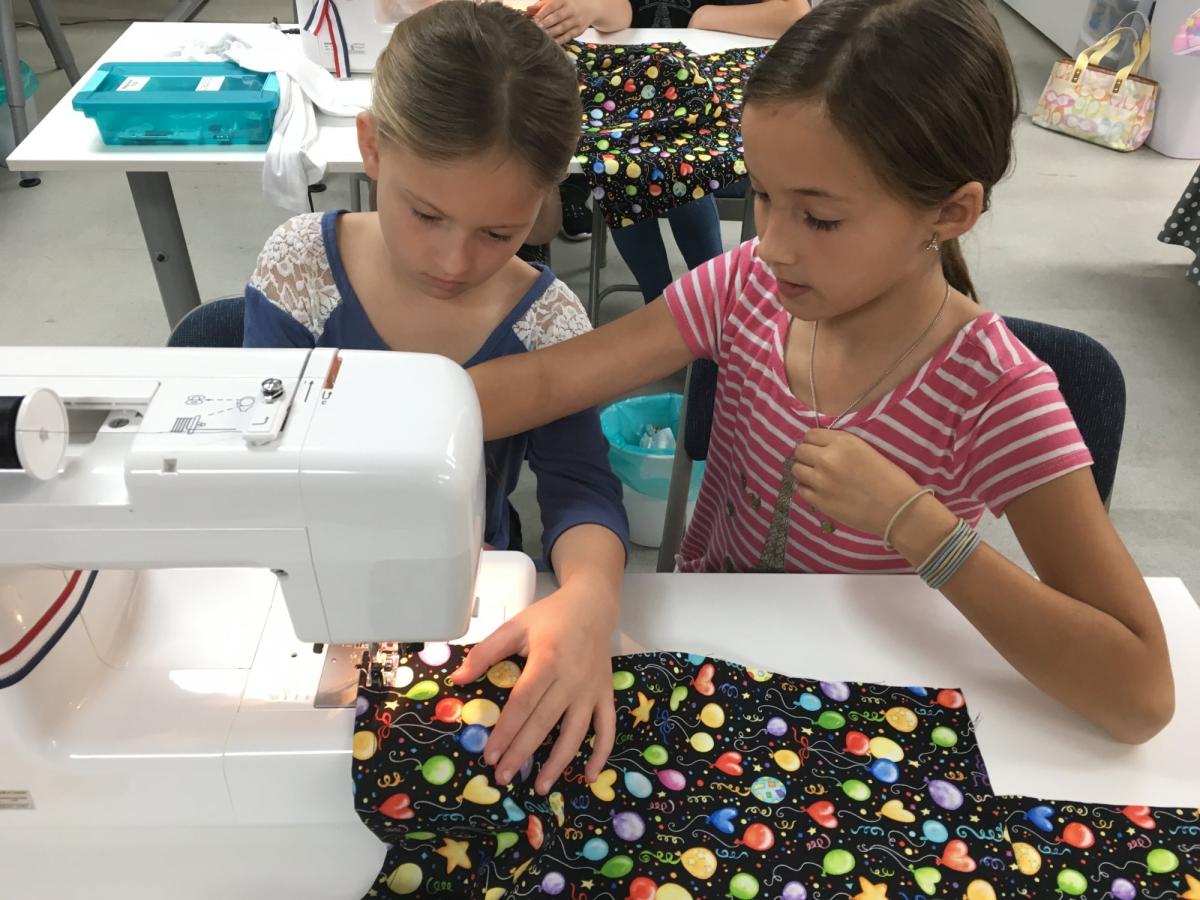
left=245, top=0, right=628, bottom=793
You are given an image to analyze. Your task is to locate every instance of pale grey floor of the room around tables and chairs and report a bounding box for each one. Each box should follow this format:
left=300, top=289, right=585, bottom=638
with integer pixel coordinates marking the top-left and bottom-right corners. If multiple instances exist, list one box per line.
left=0, top=0, right=1200, bottom=596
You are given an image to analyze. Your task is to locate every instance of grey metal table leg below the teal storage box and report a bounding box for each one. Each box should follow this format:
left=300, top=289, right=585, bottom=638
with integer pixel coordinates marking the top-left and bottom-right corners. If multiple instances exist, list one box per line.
left=127, top=172, right=200, bottom=328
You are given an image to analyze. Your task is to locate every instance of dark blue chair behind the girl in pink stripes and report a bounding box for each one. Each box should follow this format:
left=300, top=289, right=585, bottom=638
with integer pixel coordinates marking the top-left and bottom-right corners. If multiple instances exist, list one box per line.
left=658, top=317, right=1126, bottom=572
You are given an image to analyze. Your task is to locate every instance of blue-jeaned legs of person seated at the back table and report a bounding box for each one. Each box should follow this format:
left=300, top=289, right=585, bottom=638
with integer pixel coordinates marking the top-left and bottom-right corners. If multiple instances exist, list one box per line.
left=612, top=194, right=722, bottom=302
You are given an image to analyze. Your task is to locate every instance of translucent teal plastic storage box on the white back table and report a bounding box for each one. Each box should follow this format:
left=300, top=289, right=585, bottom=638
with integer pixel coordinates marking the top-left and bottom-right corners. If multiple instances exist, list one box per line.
left=72, top=61, right=280, bottom=145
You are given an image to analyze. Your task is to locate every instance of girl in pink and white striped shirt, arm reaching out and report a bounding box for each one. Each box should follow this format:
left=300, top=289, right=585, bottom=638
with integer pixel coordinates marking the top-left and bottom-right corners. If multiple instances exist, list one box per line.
left=472, top=0, right=1174, bottom=742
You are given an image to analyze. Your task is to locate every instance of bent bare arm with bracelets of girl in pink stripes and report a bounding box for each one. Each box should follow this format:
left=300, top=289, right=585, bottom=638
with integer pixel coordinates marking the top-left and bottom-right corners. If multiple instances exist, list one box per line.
left=792, top=428, right=1175, bottom=744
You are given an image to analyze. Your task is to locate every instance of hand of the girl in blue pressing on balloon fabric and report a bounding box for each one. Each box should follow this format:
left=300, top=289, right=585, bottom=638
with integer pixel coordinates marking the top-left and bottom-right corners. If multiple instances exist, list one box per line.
left=450, top=589, right=618, bottom=794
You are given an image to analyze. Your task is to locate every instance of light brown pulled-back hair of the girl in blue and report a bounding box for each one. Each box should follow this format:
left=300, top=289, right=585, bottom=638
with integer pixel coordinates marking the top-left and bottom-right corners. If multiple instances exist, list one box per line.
left=372, top=0, right=582, bottom=187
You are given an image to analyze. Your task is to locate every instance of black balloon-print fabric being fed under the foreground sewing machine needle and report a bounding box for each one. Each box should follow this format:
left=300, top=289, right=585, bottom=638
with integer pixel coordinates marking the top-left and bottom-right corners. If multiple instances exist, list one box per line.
left=353, top=644, right=1022, bottom=900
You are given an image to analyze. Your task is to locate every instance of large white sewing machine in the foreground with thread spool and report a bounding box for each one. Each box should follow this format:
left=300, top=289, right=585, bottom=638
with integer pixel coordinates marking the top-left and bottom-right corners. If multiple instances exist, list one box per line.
left=0, top=348, right=534, bottom=854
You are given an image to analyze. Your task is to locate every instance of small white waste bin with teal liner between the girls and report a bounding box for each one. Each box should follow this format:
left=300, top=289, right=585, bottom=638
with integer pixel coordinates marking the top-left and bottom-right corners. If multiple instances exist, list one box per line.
left=600, top=394, right=704, bottom=547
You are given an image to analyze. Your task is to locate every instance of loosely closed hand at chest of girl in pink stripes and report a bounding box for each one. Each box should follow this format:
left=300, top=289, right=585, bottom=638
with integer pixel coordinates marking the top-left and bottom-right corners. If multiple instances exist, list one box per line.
left=792, top=428, right=919, bottom=536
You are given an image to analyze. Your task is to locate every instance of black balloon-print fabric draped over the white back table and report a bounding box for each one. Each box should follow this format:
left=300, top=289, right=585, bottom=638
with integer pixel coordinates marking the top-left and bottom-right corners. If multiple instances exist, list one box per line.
left=566, top=41, right=767, bottom=228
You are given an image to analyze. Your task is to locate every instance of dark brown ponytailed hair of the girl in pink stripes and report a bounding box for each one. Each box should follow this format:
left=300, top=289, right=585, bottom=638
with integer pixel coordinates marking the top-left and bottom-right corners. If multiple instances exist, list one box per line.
left=746, top=0, right=1020, bottom=298
